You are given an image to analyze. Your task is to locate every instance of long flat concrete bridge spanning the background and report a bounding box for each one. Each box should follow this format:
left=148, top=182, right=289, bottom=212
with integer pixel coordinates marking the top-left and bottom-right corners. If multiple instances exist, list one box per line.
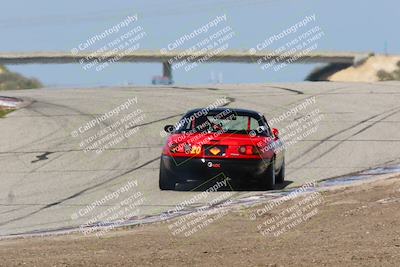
left=0, top=50, right=373, bottom=79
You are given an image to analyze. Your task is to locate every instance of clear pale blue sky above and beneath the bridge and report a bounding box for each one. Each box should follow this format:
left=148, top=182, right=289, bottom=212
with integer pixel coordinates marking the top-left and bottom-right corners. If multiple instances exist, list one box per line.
left=0, top=0, right=400, bottom=87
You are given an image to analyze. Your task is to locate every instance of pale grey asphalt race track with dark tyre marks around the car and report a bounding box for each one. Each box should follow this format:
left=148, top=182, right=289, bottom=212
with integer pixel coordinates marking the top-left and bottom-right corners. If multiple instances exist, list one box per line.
left=0, top=82, right=400, bottom=236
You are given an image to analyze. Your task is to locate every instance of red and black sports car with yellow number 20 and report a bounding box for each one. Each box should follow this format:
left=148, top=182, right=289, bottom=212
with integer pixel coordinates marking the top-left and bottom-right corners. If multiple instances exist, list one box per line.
left=159, top=108, right=285, bottom=190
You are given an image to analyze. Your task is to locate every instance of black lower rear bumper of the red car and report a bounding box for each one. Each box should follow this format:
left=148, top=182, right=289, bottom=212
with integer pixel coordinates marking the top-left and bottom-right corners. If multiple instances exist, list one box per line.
left=161, top=155, right=270, bottom=182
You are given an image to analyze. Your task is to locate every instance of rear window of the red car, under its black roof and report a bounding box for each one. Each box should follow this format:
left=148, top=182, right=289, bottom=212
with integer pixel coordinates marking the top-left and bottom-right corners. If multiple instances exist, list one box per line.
left=176, top=110, right=262, bottom=134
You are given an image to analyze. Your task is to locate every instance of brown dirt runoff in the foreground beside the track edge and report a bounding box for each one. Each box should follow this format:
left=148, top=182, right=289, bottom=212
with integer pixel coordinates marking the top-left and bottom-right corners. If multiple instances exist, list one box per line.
left=0, top=177, right=400, bottom=266
